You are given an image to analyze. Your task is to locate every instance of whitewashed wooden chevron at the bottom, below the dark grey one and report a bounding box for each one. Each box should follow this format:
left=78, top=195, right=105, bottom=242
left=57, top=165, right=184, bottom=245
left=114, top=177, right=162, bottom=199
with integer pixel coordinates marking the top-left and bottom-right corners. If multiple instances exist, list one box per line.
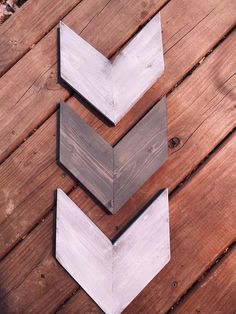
left=56, top=189, right=170, bottom=314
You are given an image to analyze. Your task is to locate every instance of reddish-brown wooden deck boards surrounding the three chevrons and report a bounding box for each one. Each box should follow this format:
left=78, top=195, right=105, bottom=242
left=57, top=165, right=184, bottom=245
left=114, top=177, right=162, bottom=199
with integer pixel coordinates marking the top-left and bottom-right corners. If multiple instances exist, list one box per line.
left=0, top=0, right=236, bottom=314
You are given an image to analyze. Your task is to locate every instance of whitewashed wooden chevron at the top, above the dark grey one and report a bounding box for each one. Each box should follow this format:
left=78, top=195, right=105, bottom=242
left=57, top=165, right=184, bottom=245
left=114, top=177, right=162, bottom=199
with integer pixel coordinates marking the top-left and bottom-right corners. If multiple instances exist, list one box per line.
left=60, top=14, right=164, bottom=124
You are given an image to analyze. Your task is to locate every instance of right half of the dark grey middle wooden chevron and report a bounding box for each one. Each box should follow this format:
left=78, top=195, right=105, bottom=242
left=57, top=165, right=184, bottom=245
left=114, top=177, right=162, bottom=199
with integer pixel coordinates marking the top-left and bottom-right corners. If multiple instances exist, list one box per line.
left=114, top=97, right=168, bottom=212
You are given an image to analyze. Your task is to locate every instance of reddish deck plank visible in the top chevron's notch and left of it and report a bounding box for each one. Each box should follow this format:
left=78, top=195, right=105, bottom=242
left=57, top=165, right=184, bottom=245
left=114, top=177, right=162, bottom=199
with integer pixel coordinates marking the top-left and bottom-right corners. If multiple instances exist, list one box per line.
left=0, top=0, right=167, bottom=161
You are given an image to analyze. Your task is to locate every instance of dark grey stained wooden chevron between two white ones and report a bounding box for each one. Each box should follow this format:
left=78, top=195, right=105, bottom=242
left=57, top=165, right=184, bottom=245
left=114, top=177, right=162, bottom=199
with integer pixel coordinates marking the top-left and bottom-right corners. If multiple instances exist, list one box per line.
left=59, top=98, right=168, bottom=213
